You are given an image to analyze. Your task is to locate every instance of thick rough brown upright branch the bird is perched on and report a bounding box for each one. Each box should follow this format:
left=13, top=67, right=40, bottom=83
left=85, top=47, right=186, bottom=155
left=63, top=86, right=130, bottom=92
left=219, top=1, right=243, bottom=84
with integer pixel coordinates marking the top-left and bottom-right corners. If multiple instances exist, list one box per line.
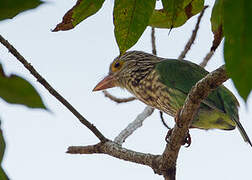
left=160, top=66, right=228, bottom=178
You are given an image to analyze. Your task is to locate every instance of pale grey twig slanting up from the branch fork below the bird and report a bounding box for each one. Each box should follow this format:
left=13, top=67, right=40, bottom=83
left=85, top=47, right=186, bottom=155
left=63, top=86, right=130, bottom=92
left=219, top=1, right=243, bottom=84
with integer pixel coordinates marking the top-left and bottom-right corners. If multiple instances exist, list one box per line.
left=114, top=106, right=154, bottom=145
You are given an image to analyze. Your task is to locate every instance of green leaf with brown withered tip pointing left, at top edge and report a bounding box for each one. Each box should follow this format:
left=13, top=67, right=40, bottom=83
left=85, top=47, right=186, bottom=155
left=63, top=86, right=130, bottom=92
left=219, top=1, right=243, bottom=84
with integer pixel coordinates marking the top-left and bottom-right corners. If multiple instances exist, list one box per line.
left=53, top=0, right=105, bottom=32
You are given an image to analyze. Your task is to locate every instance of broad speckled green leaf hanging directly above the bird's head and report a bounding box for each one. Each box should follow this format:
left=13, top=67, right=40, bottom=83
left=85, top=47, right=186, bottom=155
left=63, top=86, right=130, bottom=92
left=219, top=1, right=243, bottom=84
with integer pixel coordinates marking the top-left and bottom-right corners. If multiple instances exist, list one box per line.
left=113, top=0, right=156, bottom=54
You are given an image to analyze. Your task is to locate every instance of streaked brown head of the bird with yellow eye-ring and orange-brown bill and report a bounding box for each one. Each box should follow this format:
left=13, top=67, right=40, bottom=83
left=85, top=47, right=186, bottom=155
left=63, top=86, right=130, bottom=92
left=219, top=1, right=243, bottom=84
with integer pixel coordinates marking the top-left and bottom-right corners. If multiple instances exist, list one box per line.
left=93, top=51, right=161, bottom=91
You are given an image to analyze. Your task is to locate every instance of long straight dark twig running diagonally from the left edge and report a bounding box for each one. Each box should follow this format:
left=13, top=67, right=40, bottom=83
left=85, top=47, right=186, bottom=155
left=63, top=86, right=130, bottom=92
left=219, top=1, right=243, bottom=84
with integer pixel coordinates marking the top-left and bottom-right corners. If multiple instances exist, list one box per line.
left=0, top=35, right=108, bottom=142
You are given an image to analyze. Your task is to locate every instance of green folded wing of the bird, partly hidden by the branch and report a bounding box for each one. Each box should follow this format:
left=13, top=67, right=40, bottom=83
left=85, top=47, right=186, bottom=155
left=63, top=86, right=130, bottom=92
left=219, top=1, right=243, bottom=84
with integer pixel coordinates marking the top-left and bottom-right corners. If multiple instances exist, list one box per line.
left=156, top=59, right=239, bottom=120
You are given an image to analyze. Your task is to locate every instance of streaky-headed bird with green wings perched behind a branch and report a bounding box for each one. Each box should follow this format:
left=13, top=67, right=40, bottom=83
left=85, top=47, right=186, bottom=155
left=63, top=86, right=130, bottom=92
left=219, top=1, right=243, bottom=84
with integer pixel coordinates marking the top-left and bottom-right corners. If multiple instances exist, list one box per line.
left=93, top=51, right=252, bottom=146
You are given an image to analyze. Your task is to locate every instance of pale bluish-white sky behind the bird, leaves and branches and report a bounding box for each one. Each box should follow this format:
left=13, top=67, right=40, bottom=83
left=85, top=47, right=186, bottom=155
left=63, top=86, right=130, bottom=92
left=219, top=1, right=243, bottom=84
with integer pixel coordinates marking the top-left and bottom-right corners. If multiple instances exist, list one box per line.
left=0, top=0, right=252, bottom=180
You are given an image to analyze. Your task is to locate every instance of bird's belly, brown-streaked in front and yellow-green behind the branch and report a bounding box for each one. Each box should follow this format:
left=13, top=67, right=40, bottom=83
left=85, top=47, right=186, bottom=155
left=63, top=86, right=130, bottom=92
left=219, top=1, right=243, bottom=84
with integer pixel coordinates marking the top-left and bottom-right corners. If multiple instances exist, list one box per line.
left=132, top=85, right=235, bottom=130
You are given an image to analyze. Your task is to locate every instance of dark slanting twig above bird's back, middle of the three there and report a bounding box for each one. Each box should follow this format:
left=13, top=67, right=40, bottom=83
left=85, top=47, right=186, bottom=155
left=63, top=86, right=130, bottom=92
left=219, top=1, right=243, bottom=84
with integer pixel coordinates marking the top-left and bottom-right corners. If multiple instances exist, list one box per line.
left=178, top=6, right=208, bottom=60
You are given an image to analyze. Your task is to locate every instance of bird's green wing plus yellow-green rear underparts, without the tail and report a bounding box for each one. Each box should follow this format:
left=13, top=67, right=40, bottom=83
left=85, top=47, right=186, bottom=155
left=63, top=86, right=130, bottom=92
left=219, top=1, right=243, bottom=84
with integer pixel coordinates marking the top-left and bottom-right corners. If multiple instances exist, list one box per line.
left=154, top=59, right=239, bottom=130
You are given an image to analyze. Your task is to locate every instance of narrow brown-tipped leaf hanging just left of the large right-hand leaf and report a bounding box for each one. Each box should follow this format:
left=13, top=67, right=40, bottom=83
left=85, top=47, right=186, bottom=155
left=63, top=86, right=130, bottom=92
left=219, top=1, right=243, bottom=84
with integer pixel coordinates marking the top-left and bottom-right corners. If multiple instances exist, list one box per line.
left=211, top=0, right=223, bottom=51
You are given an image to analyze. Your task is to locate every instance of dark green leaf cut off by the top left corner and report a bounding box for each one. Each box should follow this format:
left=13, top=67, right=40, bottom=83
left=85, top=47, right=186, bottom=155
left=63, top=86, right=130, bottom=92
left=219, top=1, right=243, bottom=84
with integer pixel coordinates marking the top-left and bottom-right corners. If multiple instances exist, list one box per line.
left=0, top=0, right=43, bottom=21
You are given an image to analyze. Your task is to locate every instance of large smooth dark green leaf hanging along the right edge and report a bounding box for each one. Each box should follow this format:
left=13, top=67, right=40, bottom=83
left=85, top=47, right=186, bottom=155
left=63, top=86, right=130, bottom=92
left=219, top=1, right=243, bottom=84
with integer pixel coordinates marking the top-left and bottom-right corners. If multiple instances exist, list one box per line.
left=224, top=0, right=252, bottom=101
